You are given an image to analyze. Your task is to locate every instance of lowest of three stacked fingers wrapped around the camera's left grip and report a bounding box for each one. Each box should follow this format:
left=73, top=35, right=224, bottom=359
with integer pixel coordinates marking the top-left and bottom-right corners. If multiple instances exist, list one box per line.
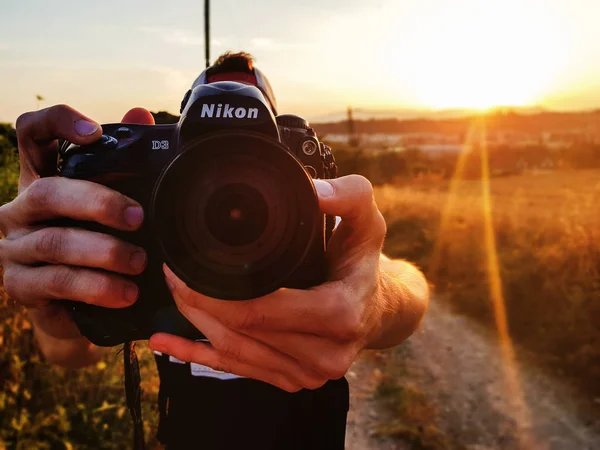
left=4, top=264, right=138, bottom=308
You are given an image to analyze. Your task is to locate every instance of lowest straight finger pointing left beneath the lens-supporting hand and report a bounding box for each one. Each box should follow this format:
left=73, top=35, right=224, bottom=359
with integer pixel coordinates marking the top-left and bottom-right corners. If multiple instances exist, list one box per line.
left=149, top=333, right=302, bottom=392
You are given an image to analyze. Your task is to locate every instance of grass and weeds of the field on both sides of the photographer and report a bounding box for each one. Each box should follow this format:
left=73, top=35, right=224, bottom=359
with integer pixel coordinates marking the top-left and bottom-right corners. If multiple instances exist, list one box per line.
left=0, top=127, right=600, bottom=450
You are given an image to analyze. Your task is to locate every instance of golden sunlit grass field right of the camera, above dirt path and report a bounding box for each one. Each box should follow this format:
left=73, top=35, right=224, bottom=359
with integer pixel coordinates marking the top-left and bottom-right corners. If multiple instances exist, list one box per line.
left=376, top=170, right=600, bottom=397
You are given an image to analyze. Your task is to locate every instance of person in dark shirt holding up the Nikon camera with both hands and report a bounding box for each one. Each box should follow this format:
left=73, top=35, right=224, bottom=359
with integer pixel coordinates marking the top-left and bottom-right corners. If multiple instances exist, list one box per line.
left=0, top=53, right=429, bottom=450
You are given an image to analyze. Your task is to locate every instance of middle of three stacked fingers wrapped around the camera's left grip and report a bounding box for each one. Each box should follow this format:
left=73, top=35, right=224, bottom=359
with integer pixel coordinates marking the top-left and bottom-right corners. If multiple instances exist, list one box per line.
left=0, top=227, right=146, bottom=275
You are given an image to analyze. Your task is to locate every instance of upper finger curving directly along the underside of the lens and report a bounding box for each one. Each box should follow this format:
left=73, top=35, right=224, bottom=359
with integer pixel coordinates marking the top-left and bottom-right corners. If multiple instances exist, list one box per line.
left=163, top=265, right=358, bottom=338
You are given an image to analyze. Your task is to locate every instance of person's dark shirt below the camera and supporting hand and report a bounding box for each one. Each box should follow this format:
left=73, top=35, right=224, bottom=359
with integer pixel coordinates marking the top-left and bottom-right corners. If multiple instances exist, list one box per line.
left=155, top=355, right=349, bottom=450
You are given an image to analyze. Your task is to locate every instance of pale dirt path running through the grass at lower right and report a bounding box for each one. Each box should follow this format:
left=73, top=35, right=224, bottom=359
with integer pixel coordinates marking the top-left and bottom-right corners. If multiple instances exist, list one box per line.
left=347, top=302, right=600, bottom=450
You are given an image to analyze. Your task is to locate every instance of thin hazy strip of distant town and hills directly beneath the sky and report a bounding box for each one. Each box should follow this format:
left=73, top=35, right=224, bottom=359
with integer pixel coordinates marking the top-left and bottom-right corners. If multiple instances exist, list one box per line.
left=313, top=110, right=600, bottom=154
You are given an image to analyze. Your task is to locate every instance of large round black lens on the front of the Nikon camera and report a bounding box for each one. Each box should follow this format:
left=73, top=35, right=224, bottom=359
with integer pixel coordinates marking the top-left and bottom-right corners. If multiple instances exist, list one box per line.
left=150, top=131, right=324, bottom=299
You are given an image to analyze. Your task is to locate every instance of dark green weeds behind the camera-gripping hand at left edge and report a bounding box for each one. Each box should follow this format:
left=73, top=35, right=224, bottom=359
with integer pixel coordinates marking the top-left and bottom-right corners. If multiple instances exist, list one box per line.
left=0, top=124, right=158, bottom=450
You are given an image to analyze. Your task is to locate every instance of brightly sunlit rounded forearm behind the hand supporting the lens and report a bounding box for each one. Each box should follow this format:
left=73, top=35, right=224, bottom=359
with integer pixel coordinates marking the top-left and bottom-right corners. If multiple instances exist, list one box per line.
left=366, top=254, right=429, bottom=348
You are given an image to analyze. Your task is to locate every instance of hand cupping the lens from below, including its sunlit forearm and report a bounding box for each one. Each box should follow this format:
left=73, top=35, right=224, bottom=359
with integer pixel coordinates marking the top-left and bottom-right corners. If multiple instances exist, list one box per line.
left=150, top=175, right=428, bottom=392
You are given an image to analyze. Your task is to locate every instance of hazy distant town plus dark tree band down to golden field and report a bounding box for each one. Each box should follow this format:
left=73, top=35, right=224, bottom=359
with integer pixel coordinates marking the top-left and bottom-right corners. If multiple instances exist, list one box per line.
left=312, top=109, right=600, bottom=177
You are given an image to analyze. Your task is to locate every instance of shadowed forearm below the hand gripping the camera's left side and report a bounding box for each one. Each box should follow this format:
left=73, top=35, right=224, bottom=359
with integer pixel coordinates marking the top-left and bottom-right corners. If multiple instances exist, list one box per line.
left=28, top=307, right=104, bottom=369
